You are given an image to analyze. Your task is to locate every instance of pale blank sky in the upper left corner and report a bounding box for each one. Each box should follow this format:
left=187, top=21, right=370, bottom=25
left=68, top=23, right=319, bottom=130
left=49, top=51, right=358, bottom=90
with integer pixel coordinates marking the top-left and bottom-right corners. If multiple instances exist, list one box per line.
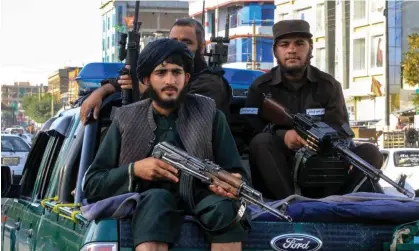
left=0, top=0, right=102, bottom=84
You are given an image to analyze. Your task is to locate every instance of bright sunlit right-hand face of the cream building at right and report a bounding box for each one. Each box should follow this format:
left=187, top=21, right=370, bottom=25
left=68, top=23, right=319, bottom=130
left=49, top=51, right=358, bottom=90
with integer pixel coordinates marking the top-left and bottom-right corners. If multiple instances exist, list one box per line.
left=344, top=0, right=388, bottom=122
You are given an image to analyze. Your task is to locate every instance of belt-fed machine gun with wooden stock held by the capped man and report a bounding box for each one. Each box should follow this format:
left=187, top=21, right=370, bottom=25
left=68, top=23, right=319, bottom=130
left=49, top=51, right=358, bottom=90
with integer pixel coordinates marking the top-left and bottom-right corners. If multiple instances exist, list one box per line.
left=260, top=95, right=415, bottom=198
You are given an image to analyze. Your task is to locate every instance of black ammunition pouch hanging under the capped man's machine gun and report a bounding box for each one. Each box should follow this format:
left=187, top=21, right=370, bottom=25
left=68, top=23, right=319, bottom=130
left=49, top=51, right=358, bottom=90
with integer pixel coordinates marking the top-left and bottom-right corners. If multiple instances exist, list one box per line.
left=292, top=147, right=349, bottom=197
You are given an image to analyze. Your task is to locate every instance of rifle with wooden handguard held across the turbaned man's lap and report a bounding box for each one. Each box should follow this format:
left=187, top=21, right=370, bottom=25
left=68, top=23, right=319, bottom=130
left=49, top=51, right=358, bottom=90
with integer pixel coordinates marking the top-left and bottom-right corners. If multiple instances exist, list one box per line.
left=152, top=142, right=292, bottom=222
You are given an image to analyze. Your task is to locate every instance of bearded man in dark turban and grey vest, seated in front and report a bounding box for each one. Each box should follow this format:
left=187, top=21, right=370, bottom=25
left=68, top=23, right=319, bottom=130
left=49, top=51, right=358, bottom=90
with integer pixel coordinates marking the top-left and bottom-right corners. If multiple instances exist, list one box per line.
left=83, top=39, right=249, bottom=250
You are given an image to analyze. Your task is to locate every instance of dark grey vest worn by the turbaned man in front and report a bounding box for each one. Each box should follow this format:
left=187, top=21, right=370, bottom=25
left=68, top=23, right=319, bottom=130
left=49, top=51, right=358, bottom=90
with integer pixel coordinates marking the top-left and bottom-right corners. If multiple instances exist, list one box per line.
left=114, top=94, right=216, bottom=207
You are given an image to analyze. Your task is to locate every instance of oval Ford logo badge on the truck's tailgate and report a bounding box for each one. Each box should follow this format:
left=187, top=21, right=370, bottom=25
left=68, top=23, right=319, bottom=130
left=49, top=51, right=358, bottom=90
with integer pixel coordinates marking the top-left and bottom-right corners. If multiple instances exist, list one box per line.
left=271, top=234, right=323, bottom=251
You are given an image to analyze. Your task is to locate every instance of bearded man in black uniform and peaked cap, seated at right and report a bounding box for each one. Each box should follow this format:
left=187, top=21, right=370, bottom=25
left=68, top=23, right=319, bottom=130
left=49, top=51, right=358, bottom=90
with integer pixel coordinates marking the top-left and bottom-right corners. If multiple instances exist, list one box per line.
left=243, top=20, right=383, bottom=199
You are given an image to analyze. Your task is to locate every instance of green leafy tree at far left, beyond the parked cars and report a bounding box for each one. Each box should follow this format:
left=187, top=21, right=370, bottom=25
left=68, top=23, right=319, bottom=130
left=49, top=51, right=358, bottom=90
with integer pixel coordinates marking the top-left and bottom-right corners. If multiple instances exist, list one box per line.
left=22, top=93, right=60, bottom=123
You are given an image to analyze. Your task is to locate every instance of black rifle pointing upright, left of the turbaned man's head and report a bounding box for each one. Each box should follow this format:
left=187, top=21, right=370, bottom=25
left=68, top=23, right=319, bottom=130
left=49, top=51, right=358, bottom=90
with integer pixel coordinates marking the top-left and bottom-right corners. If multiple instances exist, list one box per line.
left=119, top=1, right=142, bottom=105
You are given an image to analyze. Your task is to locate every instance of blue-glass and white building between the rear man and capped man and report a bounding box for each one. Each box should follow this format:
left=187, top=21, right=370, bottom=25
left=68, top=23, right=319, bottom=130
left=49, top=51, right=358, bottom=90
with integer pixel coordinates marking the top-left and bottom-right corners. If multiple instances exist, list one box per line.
left=189, top=0, right=275, bottom=70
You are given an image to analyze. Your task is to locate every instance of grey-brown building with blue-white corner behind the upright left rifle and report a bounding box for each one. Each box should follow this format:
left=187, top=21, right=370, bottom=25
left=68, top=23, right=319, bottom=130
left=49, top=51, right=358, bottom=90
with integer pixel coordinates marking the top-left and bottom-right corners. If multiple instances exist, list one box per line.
left=100, top=0, right=188, bottom=62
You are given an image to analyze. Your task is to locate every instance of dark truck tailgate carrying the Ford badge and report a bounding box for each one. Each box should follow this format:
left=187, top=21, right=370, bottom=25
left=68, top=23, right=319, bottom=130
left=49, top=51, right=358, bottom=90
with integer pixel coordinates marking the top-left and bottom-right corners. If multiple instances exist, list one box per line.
left=119, top=218, right=396, bottom=251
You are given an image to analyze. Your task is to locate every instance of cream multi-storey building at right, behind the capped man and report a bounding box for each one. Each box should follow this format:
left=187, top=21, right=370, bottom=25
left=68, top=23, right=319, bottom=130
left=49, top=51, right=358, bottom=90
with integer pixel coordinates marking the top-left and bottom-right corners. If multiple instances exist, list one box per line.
left=275, top=0, right=419, bottom=125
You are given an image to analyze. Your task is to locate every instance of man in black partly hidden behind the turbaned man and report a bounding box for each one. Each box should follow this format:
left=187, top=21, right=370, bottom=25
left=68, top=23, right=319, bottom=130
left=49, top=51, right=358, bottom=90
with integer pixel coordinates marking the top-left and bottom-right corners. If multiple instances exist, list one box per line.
left=80, top=18, right=232, bottom=123
